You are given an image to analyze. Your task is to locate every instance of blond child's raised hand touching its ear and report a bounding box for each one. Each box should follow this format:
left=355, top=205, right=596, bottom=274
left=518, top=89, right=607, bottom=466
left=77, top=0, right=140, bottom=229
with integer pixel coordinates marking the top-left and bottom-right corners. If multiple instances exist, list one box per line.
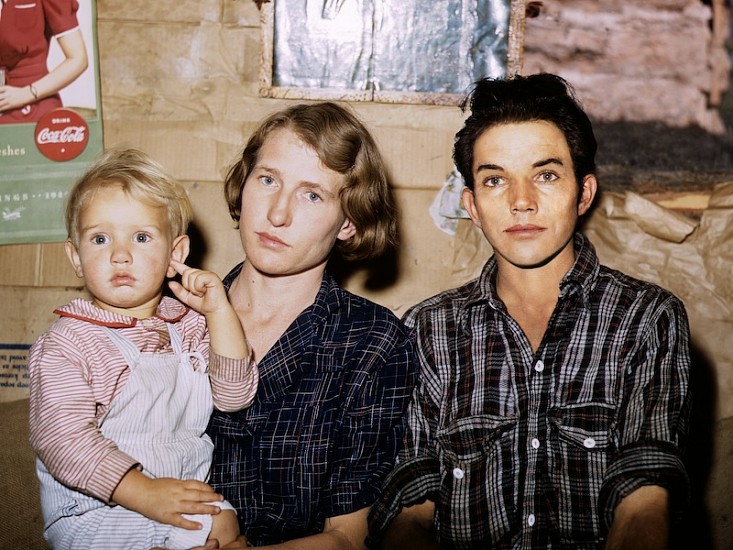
left=168, top=260, right=229, bottom=315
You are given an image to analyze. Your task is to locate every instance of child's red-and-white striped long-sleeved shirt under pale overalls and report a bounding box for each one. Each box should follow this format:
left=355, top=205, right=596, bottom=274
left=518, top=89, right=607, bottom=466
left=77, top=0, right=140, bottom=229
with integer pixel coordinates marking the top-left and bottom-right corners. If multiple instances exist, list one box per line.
left=28, top=297, right=258, bottom=502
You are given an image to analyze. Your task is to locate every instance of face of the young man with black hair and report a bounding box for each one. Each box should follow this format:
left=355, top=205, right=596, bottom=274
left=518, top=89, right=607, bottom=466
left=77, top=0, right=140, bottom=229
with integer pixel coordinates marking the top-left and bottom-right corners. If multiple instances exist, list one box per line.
left=463, top=121, right=596, bottom=269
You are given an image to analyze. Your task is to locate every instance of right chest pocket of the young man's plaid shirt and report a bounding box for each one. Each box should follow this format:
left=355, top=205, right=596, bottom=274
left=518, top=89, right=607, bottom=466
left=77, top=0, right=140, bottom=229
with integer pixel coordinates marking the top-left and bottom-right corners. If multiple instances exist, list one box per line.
left=548, top=403, right=616, bottom=542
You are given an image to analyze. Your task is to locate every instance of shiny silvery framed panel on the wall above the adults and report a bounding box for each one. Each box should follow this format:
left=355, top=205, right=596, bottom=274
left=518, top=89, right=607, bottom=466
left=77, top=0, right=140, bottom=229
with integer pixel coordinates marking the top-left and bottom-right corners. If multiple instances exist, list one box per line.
left=260, top=0, right=525, bottom=104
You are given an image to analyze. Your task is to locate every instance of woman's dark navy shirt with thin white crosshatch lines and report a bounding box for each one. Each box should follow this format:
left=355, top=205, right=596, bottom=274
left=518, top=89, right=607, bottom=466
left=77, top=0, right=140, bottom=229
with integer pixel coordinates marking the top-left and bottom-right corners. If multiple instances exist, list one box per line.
left=208, top=266, right=415, bottom=545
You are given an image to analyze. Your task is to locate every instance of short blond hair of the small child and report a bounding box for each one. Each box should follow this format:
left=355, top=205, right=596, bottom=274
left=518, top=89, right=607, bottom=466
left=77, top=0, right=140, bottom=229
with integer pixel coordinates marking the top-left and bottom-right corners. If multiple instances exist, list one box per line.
left=66, top=148, right=193, bottom=247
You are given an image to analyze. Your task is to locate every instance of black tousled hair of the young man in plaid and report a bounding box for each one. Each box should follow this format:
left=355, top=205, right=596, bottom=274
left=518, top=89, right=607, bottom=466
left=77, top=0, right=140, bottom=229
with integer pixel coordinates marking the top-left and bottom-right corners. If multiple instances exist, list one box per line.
left=453, top=73, right=597, bottom=189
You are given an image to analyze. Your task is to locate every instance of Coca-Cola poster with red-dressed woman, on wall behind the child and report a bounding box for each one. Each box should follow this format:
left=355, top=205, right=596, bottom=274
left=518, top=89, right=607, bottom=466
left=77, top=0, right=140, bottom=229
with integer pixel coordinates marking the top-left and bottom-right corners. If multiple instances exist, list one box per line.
left=0, top=0, right=104, bottom=245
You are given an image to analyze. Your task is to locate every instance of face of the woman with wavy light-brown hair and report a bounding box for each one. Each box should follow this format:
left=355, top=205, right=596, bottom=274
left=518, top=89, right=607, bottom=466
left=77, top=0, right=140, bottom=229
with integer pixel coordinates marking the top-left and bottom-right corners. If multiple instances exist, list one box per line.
left=239, top=129, right=355, bottom=276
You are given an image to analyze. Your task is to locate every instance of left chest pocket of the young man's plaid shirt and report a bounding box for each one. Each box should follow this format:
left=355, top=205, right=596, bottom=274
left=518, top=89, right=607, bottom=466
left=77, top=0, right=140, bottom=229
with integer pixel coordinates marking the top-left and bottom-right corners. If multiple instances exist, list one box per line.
left=436, top=415, right=517, bottom=548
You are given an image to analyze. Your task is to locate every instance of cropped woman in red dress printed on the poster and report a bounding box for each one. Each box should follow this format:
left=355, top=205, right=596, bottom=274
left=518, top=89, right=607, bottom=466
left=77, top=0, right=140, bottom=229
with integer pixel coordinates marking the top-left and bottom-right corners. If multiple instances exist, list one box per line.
left=0, top=0, right=88, bottom=124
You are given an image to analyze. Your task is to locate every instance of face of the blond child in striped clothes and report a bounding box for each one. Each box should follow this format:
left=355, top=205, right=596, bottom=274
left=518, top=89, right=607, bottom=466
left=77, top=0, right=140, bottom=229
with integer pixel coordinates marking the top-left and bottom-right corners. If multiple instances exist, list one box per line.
left=67, top=186, right=173, bottom=317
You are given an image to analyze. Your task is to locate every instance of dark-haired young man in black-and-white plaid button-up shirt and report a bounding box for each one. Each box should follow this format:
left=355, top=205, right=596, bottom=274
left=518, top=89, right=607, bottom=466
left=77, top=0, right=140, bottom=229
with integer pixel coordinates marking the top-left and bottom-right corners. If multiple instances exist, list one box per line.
left=369, top=74, right=690, bottom=550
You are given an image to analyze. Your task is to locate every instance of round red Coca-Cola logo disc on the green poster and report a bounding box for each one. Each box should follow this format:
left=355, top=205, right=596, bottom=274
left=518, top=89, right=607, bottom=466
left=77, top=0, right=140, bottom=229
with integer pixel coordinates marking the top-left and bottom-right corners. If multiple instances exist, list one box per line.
left=36, top=107, right=89, bottom=162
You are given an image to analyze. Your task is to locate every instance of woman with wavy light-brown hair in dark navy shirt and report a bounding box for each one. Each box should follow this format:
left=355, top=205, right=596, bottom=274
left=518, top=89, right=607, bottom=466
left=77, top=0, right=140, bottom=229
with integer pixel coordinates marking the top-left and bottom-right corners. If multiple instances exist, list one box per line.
left=208, top=102, right=415, bottom=550
